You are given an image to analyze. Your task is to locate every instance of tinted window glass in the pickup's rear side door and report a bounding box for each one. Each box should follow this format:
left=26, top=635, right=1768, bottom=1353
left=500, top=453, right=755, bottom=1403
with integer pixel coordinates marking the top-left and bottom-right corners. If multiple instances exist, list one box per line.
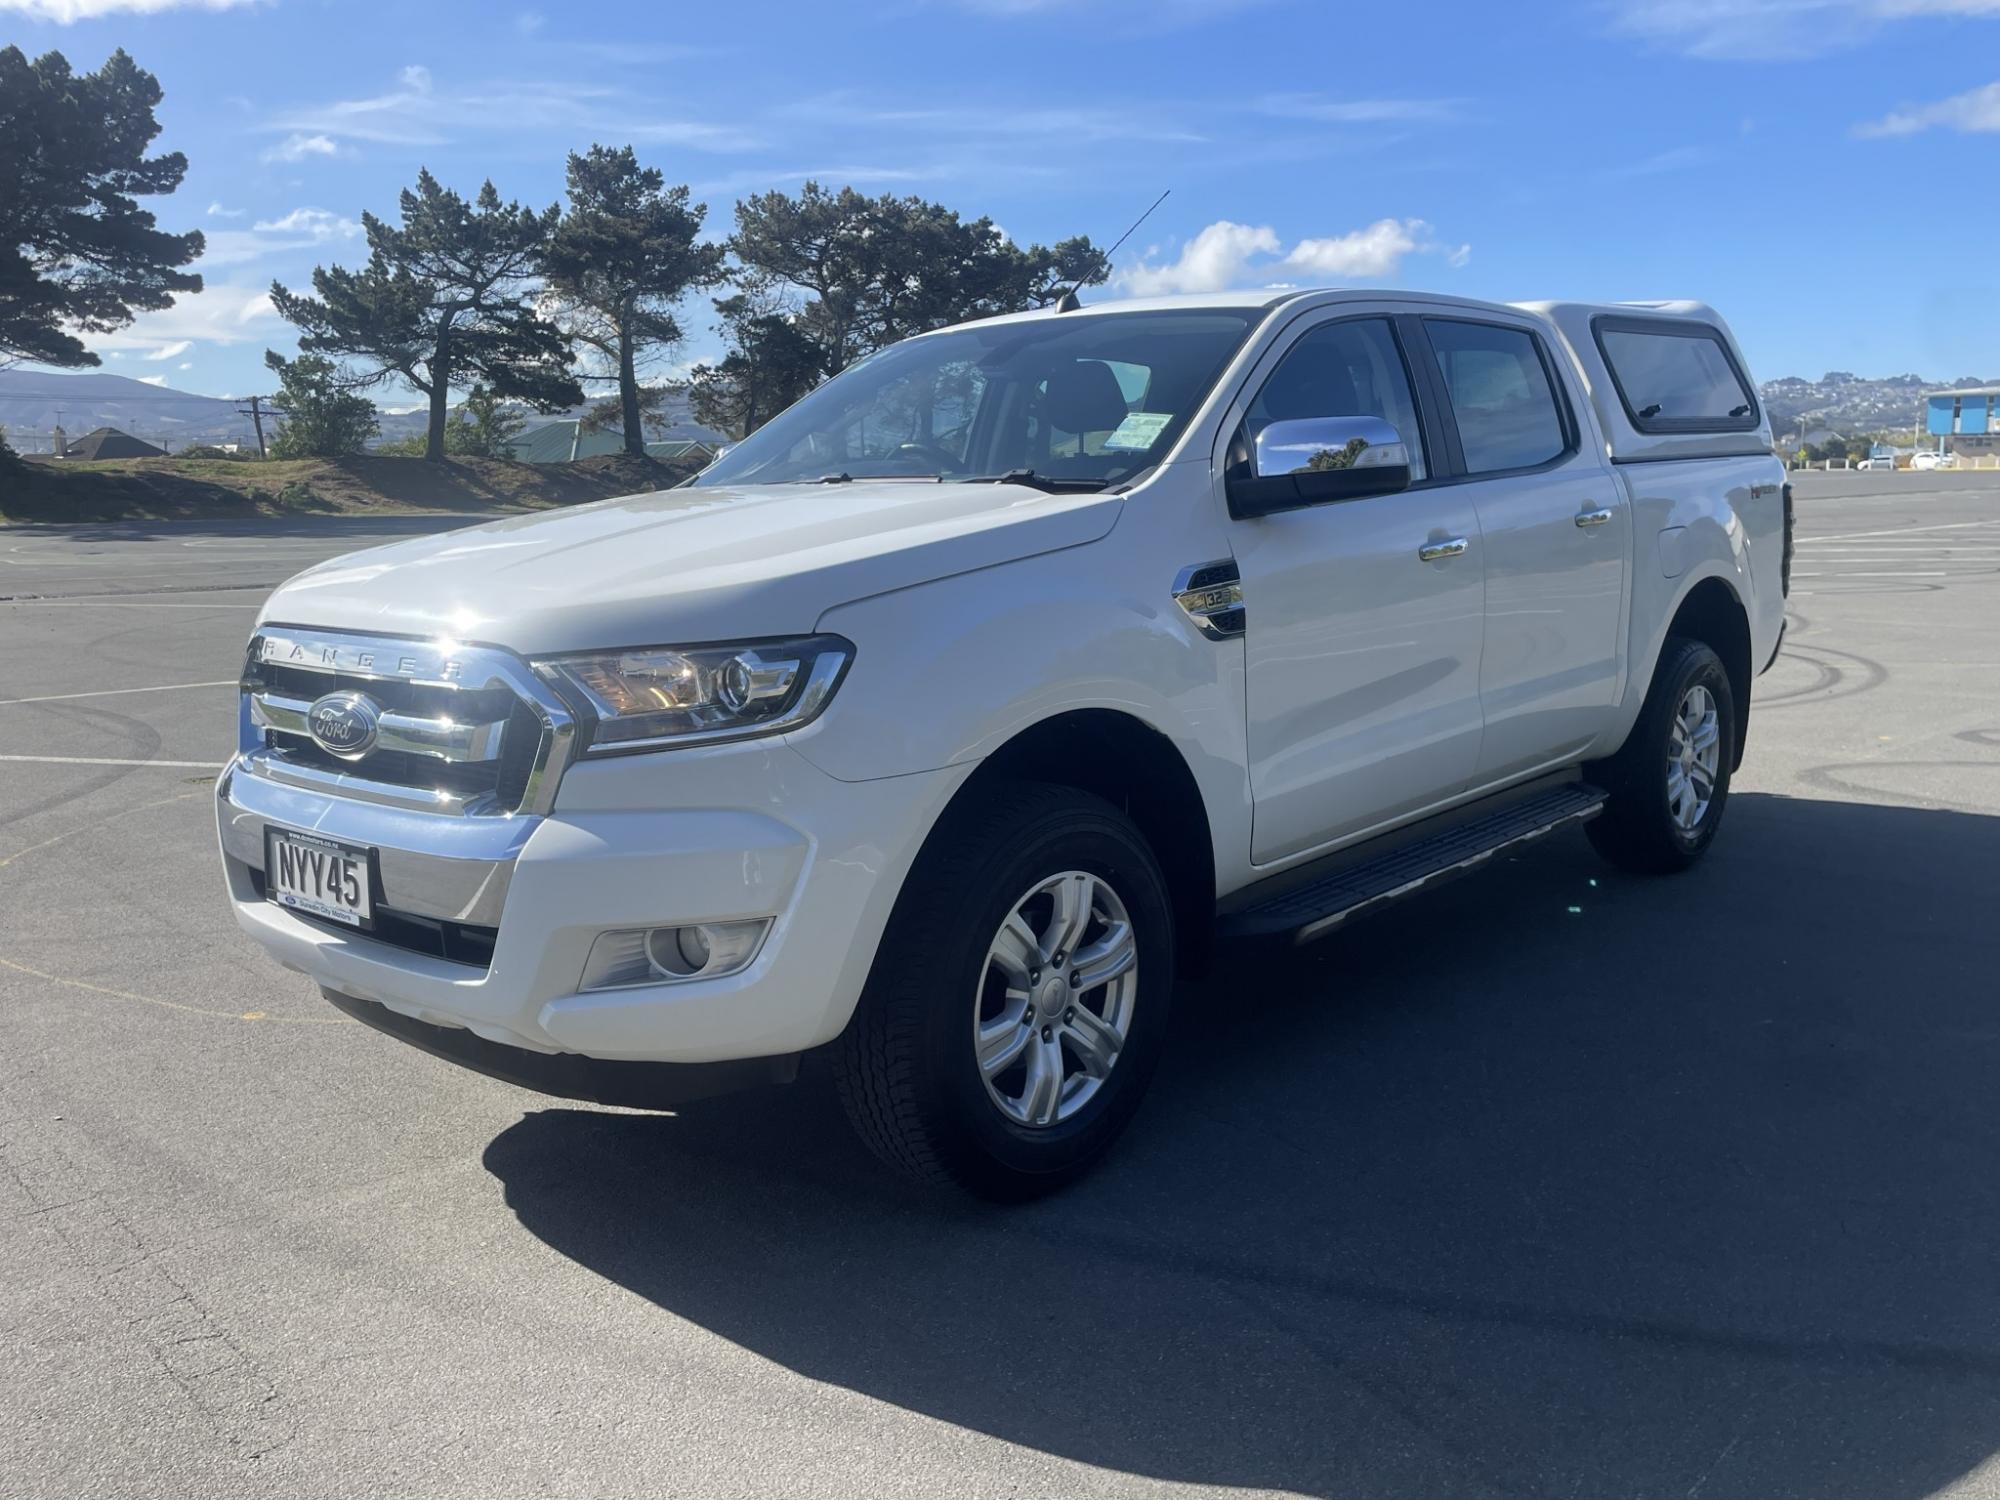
left=1424, top=318, right=1570, bottom=474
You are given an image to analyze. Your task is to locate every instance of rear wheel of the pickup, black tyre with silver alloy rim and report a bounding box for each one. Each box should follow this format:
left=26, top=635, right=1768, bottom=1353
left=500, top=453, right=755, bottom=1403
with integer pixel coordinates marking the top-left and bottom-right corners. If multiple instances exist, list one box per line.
left=1586, top=636, right=1736, bottom=874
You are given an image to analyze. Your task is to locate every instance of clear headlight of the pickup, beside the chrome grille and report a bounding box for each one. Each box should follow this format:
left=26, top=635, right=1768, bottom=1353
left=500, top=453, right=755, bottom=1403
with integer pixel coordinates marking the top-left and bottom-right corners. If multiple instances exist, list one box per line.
left=534, top=636, right=854, bottom=754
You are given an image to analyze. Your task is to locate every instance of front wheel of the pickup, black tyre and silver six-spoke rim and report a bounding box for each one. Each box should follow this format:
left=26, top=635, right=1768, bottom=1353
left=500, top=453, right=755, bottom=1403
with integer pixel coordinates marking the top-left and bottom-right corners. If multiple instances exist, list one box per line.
left=834, top=784, right=1174, bottom=1200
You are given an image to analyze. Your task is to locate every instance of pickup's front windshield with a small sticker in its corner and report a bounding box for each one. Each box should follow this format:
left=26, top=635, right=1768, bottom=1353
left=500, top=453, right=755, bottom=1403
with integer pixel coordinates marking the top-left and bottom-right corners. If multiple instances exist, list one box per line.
left=694, top=308, right=1262, bottom=488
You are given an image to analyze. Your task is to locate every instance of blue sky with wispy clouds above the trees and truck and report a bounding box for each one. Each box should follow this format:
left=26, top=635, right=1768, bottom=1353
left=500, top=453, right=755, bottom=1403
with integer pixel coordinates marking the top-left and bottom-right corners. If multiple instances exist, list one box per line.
left=0, top=0, right=2000, bottom=394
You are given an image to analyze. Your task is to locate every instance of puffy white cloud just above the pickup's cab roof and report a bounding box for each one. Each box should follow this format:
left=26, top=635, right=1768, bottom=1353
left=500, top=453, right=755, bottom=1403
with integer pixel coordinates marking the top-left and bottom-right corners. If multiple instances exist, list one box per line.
left=1118, top=218, right=1472, bottom=296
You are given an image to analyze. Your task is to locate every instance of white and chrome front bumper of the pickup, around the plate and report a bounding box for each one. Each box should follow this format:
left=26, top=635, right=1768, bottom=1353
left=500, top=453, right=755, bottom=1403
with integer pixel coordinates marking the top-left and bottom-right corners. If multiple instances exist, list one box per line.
left=216, top=740, right=970, bottom=1092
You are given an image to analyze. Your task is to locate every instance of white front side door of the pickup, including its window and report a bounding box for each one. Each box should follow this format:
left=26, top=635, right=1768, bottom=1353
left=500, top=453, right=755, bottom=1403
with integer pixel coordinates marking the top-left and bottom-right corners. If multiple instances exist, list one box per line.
left=1230, top=316, right=1486, bottom=864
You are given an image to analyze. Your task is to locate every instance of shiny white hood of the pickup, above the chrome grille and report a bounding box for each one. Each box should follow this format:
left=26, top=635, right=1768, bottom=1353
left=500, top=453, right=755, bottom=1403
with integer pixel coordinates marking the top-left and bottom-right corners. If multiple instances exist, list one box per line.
left=258, top=480, right=1120, bottom=654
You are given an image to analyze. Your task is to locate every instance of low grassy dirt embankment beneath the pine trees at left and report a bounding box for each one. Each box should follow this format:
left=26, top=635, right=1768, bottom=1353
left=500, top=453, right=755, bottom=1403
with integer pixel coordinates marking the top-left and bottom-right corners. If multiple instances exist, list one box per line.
left=0, top=454, right=694, bottom=524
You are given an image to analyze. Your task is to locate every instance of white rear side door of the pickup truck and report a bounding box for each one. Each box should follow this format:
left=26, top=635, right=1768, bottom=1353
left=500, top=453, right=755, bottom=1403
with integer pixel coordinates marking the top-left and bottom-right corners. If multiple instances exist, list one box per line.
left=1420, top=310, right=1632, bottom=786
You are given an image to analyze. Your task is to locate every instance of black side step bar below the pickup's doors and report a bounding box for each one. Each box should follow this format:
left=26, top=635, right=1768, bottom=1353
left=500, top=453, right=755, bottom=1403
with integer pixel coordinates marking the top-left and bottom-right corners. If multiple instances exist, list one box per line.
left=1220, top=782, right=1606, bottom=942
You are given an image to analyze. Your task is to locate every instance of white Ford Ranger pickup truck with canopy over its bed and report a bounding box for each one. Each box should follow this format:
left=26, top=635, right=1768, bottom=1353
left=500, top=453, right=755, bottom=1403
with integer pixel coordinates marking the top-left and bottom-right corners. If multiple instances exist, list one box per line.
left=216, top=290, right=1790, bottom=1198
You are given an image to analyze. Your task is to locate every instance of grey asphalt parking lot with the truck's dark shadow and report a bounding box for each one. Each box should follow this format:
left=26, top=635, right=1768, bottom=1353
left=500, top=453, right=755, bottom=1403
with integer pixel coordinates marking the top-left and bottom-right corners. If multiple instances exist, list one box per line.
left=0, top=484, right=2000, bottom=1500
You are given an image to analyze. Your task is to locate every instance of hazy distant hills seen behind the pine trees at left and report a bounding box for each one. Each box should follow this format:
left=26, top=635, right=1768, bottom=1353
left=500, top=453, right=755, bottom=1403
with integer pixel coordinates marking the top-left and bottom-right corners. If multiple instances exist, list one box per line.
left=0, top=370, right=724, bottom=454
